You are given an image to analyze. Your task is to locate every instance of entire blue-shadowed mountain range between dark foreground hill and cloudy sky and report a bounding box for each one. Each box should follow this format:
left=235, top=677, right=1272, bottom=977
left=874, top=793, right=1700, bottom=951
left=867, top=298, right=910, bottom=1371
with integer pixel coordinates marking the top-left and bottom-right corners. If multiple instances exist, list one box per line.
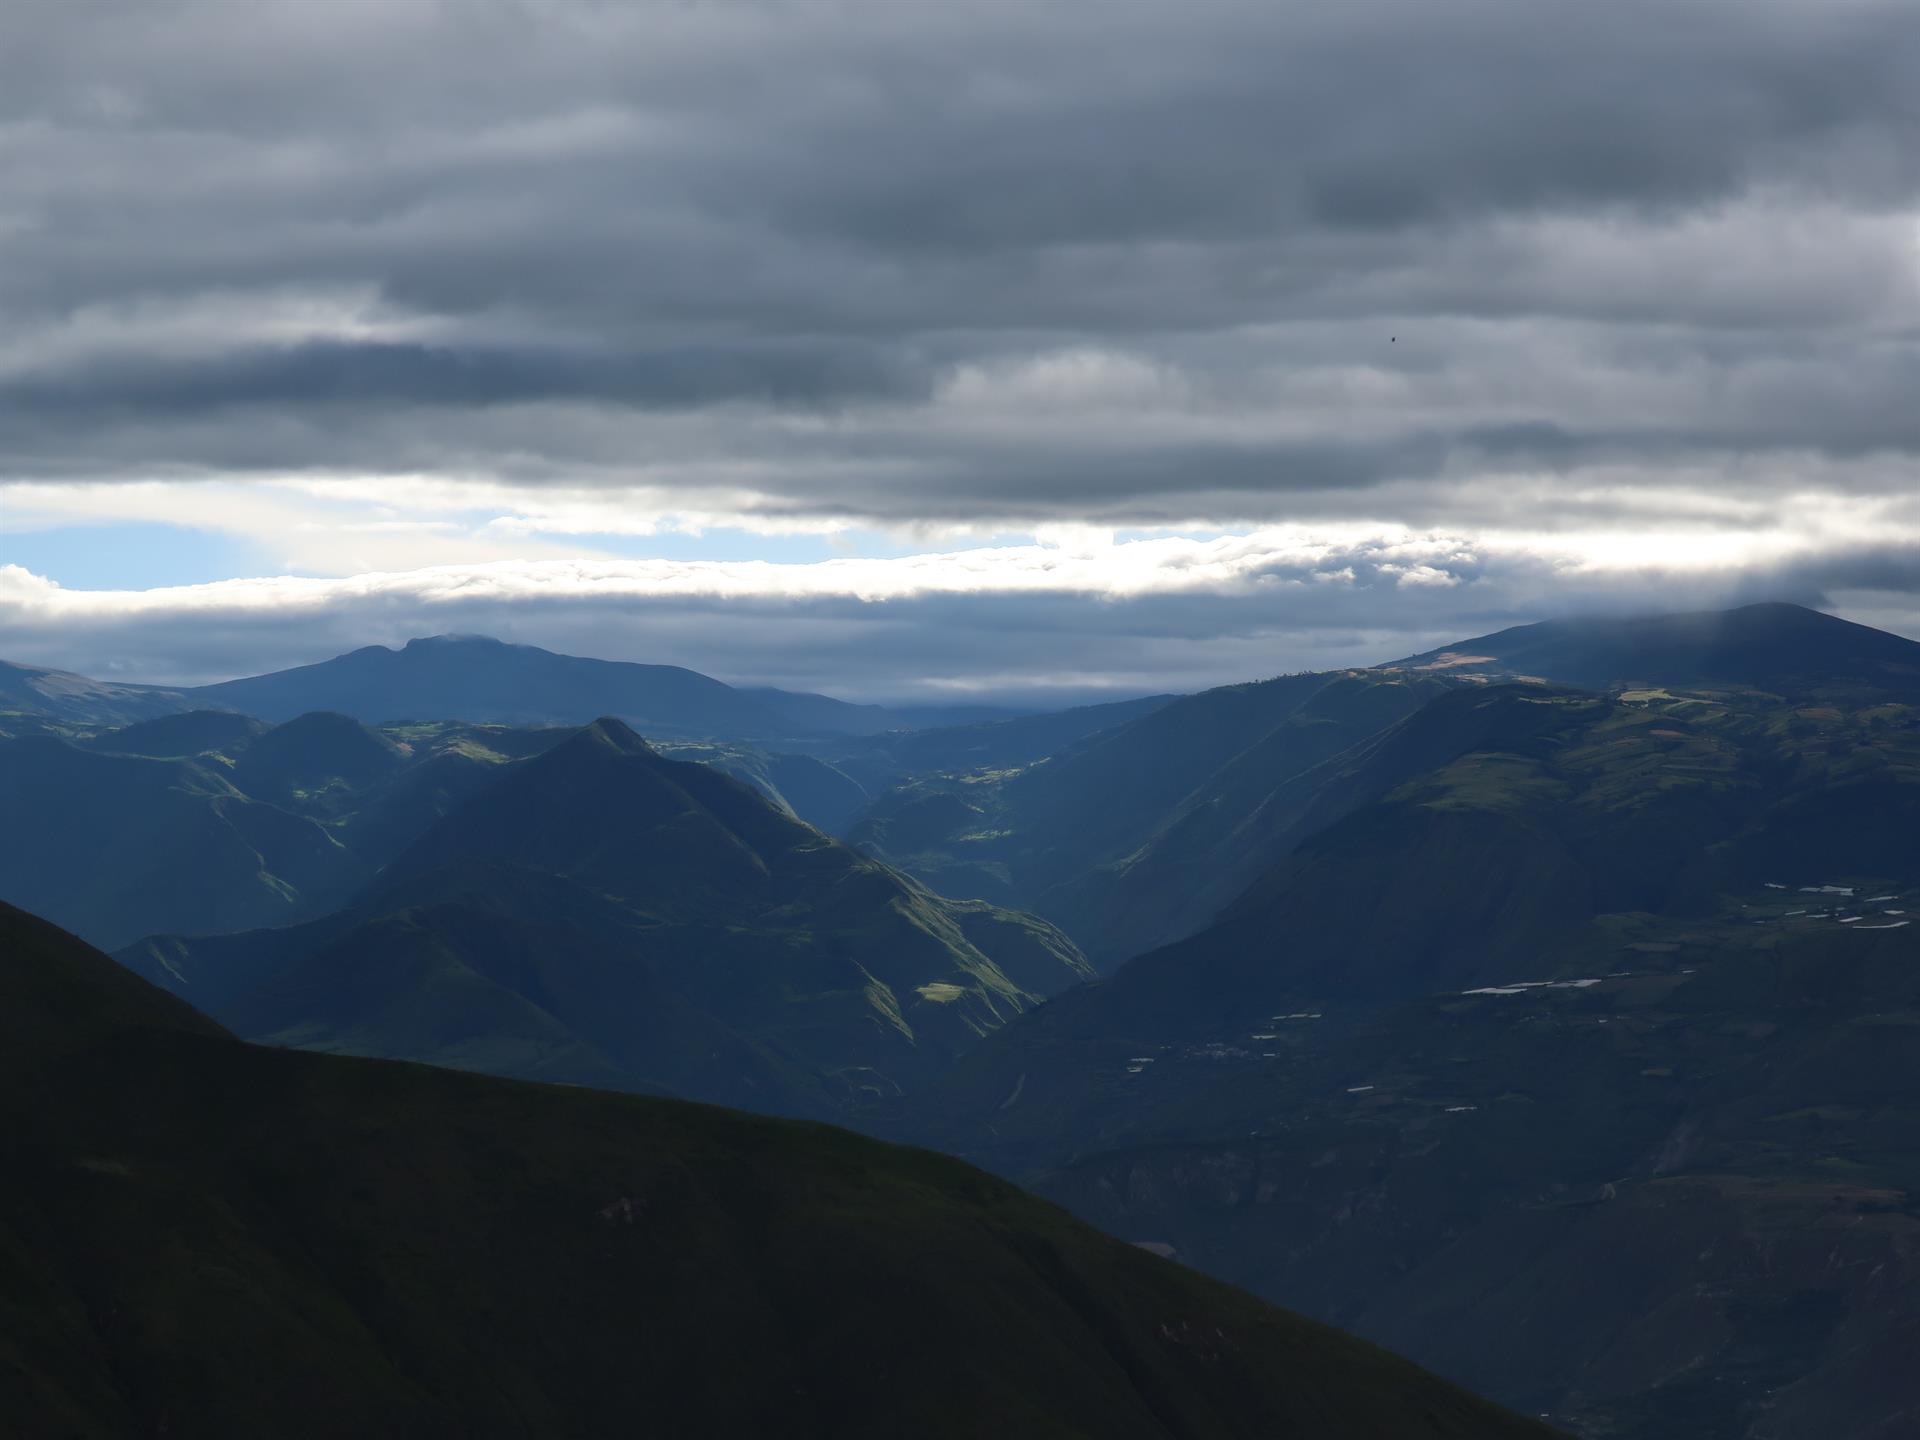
left=0, top=605, right=1920, bottom=1440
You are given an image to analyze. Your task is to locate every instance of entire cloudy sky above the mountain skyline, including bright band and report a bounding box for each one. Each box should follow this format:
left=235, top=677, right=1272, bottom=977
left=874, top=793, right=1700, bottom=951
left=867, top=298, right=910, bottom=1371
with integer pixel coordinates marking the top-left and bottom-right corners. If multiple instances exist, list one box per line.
left=0, top=0, right=1920, bottom=701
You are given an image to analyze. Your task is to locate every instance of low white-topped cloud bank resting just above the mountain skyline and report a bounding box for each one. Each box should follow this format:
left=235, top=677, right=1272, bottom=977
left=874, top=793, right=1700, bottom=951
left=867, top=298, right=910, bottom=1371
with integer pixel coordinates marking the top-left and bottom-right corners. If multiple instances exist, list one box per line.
left=0, top=530, right=1920, bottom=703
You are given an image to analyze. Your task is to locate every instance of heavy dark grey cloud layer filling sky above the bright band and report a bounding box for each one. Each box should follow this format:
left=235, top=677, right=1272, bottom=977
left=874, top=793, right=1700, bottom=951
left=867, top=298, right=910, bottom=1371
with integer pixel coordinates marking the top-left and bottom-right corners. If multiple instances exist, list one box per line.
left=0, top=0, right=1920, bottom=522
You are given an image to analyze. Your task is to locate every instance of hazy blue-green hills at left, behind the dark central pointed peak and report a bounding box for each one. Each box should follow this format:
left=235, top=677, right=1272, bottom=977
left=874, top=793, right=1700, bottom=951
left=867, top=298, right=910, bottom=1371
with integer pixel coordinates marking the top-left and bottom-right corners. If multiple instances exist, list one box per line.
left=0, top=710, right=572, bottom=945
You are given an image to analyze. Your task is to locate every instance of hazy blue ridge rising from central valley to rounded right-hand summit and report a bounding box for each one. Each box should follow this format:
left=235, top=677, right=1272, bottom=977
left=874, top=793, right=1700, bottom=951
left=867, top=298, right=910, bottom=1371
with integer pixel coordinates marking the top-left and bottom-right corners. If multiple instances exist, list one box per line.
left=847, top=605, right=1920, bottom=970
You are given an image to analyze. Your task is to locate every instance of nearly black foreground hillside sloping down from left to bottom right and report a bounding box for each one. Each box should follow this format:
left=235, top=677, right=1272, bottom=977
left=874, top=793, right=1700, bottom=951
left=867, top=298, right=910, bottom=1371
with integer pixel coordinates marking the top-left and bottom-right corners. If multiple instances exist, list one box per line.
left=0, top=906, right=1548, bottom=1440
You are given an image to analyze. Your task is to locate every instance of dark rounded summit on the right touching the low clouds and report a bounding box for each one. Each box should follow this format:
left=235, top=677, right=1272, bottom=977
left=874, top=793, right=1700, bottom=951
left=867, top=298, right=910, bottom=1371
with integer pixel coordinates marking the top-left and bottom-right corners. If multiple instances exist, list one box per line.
left=1392, top=605, right=1920, bottom=695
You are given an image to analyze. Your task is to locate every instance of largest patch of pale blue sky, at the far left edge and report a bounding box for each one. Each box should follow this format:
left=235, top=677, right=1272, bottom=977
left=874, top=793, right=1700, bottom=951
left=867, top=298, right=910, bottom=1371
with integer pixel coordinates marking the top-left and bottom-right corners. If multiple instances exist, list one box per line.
left=0, top=520, right=259, bottom=589
